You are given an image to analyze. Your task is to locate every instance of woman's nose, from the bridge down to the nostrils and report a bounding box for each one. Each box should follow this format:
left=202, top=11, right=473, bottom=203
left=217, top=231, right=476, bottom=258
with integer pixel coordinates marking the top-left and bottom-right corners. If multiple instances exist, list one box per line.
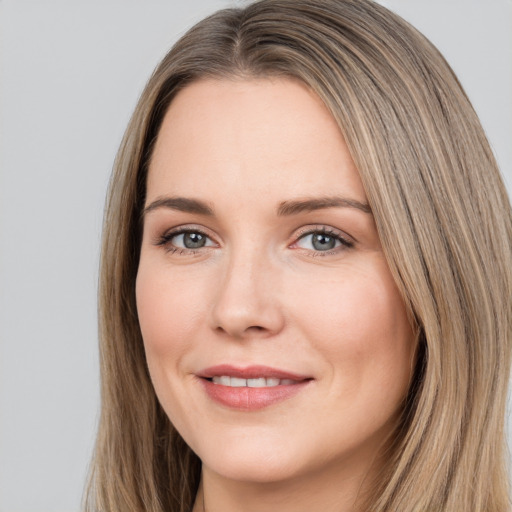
left=212, top=248, right=284, bottom=339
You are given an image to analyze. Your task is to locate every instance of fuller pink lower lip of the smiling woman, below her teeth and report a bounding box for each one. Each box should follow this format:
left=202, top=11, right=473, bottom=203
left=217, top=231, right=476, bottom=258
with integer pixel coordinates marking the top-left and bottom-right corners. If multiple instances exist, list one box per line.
left=200, top=379, right=311, bottom=411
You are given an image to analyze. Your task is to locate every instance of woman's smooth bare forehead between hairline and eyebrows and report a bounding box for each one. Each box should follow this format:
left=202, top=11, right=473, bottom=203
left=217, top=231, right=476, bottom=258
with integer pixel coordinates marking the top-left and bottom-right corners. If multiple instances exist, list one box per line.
left=147, top=78, right=365, bottom=205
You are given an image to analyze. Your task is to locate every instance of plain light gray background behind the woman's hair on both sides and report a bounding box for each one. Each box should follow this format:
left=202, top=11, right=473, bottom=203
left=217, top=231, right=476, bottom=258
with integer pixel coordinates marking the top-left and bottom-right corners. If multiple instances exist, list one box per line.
left=0, top=0, right=512, bottom=512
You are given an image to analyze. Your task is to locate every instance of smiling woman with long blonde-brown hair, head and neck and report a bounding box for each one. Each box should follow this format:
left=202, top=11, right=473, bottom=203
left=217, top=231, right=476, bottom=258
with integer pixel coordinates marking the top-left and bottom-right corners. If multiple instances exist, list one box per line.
left=84, top=0, right=512, bottom=512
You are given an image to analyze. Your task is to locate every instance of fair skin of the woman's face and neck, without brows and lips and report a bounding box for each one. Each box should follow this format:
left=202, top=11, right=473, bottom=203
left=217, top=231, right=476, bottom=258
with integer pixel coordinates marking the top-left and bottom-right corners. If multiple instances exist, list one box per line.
left=136, top=79, right=415, bottom=512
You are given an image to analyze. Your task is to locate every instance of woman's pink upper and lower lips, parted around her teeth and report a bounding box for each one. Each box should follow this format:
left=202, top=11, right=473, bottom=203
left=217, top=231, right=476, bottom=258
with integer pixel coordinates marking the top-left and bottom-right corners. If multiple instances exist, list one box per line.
left=198, top=365, right=312, bottom=411
